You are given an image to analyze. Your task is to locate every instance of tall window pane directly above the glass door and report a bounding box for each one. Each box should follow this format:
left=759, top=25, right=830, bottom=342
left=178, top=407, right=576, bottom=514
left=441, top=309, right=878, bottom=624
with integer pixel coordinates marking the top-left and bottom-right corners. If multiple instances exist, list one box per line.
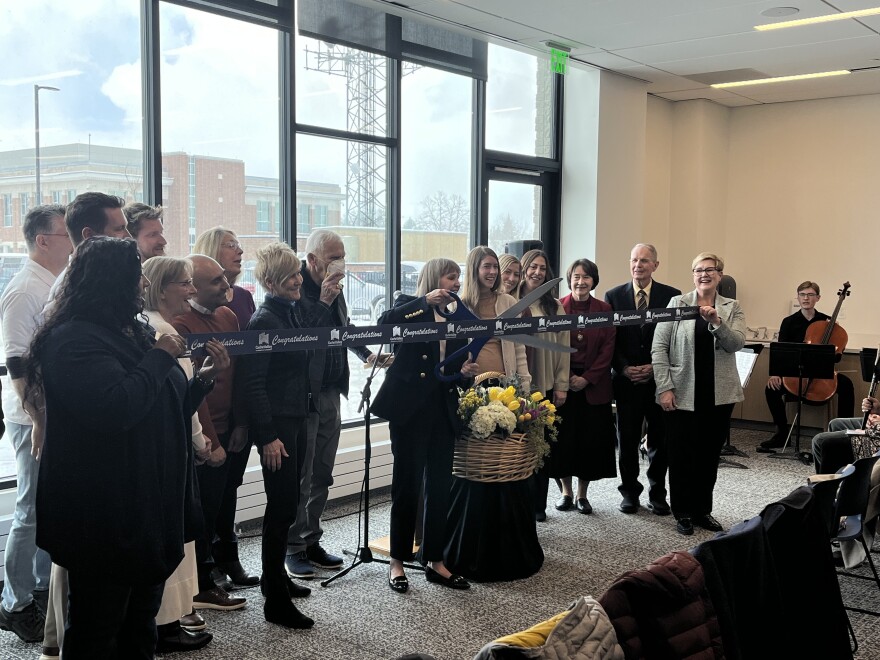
left=486, top=44, right=554, bottom=158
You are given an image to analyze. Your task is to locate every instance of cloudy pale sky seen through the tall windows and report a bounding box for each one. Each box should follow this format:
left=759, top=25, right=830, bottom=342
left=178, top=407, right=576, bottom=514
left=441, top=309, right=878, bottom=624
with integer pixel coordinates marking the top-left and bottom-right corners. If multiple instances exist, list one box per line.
left=0, top=0, right=545, bottom=223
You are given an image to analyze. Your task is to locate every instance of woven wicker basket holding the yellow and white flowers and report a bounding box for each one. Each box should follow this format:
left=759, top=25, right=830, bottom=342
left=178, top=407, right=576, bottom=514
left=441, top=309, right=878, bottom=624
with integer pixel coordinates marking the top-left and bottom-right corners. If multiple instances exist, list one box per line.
left=452, top=433, right=538, bottom=483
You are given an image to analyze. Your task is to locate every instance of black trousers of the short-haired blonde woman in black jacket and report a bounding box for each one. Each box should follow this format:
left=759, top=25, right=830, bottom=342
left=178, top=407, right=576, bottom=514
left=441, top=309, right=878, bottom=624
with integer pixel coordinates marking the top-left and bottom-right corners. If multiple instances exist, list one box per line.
left=261, top=417, right=308, bottom=598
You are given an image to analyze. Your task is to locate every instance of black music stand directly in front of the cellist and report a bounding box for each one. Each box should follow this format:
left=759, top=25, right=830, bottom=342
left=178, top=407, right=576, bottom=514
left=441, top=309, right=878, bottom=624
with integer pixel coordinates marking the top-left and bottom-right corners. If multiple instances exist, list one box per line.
left=770, top=342, right=837, bottom=465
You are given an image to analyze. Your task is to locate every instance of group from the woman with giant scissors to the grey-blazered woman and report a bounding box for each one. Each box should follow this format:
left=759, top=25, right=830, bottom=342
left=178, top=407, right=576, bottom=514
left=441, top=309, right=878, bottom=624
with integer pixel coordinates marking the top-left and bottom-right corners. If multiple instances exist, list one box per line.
left=373, top=244, right=746, bottom=593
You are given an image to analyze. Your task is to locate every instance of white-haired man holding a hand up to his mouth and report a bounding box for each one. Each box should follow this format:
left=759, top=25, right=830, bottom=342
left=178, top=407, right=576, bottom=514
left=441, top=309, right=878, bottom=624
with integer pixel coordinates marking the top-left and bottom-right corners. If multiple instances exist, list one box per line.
left=285, top=229, right=375, bottom=579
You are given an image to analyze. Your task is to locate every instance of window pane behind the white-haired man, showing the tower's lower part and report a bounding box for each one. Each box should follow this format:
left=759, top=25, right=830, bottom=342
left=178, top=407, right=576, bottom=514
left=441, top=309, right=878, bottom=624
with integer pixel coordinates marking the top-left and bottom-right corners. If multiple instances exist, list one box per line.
left=296, top=135, right=388, bottom=421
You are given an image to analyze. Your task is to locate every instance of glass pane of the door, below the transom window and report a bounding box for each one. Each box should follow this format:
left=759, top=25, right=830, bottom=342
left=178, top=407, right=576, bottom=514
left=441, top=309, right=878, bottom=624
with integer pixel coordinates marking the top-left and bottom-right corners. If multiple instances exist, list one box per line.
left=489, top=180, right=541, bottom=254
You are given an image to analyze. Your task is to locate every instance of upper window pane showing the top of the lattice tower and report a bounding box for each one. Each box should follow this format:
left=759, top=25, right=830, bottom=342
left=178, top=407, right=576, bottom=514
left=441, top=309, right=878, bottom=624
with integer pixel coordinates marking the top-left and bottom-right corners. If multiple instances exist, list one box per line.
left=294, top=36, right=388, bottom=136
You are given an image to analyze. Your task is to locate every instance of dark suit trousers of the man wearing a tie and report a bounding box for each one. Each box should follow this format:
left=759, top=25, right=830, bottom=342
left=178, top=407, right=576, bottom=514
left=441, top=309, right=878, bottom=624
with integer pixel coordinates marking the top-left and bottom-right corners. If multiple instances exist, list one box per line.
left=613, top=376, right=669, bottom=502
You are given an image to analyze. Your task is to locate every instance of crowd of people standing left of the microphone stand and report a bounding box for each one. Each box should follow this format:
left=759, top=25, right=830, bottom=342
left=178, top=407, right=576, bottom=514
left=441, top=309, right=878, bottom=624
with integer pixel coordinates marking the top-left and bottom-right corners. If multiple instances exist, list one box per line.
left=0, top=192, right=375, bottom=660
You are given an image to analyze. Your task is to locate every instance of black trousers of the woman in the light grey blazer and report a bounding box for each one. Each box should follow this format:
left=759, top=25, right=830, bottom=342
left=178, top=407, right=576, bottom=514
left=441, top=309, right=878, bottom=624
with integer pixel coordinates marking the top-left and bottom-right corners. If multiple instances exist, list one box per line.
left=665, top=403, right=733, bottom=520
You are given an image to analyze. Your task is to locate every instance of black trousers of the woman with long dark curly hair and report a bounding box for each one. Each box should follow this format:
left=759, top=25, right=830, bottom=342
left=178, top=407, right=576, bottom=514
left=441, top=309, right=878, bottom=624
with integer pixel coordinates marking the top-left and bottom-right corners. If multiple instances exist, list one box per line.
left=62, top=568, right=165, bottom=660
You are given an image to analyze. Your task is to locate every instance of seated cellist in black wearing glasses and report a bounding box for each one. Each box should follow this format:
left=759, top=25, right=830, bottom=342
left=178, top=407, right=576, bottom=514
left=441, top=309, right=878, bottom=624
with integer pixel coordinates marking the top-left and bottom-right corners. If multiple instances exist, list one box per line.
left=756, top=280, right=855, bottom=453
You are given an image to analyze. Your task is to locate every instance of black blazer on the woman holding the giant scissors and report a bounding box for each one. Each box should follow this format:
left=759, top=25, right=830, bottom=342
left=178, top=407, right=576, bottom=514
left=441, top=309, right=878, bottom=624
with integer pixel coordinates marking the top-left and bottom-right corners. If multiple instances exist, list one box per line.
left=371, top=294, right=472, bottom=434
